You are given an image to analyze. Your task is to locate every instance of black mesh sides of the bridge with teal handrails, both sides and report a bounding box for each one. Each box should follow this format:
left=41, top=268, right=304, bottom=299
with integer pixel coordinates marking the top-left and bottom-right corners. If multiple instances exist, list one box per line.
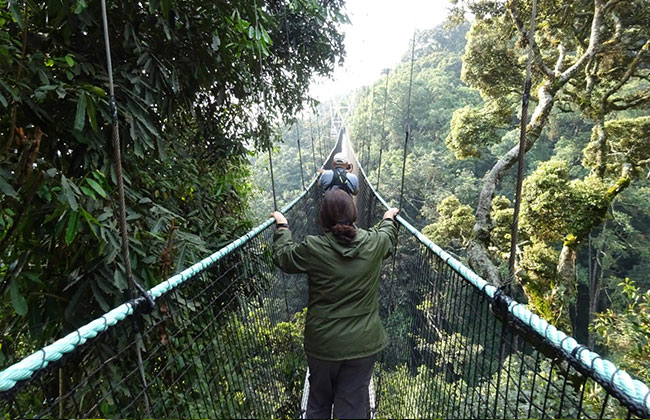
left=0, top=126, right=650, bottom=418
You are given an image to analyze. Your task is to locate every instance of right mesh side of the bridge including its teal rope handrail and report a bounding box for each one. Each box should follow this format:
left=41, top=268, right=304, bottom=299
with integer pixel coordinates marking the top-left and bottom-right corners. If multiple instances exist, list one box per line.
left=340, top=130, right=650, bottom=418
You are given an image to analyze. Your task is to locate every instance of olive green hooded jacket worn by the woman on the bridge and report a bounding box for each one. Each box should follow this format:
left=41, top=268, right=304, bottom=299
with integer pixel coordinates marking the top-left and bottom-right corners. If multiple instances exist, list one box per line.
left=273, top=219, right=397, bottom=360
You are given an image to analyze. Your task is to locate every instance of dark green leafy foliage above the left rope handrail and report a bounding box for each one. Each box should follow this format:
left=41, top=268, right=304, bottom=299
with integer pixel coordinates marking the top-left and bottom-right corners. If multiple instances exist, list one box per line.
left=0, top=0, right=346, bottom=364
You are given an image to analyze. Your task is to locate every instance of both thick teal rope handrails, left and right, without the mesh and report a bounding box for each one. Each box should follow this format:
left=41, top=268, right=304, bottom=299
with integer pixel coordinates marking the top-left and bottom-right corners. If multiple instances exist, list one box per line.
left=0, top=123, right=650, bottom=413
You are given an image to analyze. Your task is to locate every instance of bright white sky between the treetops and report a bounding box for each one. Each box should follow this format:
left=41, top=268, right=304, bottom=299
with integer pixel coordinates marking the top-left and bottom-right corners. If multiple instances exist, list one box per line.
left=310, top=0, right=450, bottom=102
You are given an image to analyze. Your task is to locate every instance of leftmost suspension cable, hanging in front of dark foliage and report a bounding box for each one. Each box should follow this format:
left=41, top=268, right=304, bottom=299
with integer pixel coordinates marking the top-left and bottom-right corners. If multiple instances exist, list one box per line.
left=101, top=0, right=153, bottom=417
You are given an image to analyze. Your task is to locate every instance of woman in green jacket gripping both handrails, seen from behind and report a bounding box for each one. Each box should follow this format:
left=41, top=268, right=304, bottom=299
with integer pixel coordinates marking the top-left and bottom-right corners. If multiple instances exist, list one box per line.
left=272, top=190, right=398, bottom=418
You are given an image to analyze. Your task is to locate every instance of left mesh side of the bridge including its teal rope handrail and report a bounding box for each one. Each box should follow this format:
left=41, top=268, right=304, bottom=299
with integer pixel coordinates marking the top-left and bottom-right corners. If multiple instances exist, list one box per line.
left=0, top=130, right=338, bottom=418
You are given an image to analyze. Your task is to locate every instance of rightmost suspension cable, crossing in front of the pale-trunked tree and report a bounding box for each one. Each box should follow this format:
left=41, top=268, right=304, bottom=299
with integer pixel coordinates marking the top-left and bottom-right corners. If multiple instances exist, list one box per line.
left=505, top=0, right=537, bottom=292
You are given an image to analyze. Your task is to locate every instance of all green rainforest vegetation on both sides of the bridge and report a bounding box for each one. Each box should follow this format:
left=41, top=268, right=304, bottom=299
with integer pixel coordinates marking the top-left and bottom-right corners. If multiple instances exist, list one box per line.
left=0, top=0, right=650, bottom=417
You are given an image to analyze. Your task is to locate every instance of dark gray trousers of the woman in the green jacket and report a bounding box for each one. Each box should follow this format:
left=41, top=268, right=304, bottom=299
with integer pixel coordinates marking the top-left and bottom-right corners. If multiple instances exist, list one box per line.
left=307, top=354, right=377, bottom=419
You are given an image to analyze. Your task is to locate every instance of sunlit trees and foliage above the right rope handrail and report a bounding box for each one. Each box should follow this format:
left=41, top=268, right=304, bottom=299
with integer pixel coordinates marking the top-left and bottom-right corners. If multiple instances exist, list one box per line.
left=342, top=1, right=650, bottom=400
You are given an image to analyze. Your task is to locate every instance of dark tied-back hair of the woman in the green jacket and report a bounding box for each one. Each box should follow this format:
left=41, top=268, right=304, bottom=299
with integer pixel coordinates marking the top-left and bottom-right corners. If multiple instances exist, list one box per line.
left=320, top=190, right=357, bottom=242
